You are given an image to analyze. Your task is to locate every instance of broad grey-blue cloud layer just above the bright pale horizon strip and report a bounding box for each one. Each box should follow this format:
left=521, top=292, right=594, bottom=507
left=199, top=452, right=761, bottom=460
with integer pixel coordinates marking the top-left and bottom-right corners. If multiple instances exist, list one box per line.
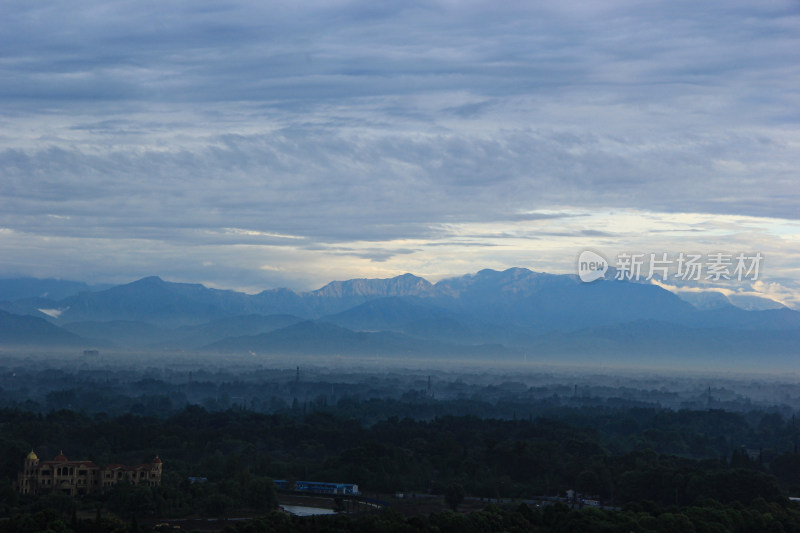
left=0, top=128, right=800, bottom=240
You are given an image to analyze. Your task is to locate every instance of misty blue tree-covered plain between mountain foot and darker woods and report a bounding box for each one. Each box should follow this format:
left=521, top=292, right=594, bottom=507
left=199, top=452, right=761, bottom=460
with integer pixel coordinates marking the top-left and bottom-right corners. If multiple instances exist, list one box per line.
left=0, top=364, right=800, bottom=423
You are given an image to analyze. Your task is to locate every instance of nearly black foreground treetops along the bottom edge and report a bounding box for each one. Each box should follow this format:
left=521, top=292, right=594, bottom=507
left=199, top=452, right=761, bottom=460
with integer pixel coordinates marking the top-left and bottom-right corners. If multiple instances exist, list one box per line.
left=6, top=499, right=800, bottom=533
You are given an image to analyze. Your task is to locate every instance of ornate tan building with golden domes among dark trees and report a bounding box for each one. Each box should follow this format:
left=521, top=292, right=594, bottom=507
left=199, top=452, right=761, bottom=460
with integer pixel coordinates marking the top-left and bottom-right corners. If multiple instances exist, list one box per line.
left=17, top=450, right=161, bottom=496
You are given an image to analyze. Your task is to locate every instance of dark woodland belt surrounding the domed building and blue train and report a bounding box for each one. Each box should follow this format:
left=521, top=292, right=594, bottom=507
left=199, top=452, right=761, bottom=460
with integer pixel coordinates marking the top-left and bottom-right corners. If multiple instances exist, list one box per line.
left=0, top=406, right=800, bottom=514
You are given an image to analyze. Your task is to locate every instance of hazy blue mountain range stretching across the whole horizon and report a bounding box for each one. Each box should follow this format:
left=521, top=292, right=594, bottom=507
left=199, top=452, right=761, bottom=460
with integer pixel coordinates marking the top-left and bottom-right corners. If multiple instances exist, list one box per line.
left=0, top=268, right=800, bottom=363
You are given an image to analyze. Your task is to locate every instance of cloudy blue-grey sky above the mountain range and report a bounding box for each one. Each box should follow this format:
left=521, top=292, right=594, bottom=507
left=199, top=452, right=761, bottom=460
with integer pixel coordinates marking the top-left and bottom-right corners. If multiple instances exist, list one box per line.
left=0, top=0, right=800, bottom=308
